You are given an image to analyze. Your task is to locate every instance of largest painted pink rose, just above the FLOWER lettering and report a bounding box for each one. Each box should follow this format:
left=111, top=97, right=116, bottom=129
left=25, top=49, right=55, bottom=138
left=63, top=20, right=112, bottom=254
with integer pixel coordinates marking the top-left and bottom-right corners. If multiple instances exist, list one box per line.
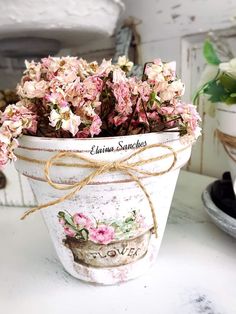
left=89, top=225, right=115, bottom=244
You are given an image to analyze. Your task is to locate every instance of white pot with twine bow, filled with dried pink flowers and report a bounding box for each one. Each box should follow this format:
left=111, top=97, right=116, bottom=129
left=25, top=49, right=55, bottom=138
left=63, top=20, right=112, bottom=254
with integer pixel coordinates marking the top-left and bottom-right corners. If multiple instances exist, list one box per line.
left=0, top=57, right=200, bottom=284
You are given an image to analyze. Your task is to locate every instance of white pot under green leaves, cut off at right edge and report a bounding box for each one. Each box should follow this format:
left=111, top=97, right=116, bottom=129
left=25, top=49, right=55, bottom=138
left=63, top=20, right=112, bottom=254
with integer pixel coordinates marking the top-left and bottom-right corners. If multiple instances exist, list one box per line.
left=216, top=103, right=236, bottom=195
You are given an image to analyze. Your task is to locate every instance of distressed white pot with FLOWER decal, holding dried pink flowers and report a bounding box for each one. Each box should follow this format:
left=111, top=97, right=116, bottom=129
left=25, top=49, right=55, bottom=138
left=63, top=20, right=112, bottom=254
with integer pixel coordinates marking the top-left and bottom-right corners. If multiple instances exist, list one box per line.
left=16, top=132, right=191, bottom=284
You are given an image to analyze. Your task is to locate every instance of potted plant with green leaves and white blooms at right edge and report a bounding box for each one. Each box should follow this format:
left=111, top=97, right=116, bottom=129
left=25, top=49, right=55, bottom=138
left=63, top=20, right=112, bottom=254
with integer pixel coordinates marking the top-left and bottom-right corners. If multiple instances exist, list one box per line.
left=194, top=40, right=236, bottom=194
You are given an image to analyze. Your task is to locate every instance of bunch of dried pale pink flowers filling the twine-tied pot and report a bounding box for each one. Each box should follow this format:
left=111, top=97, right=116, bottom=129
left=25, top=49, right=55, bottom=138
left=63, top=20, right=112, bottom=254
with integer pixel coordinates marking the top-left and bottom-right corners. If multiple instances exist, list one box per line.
left=0, top=57, right=200, bottom=166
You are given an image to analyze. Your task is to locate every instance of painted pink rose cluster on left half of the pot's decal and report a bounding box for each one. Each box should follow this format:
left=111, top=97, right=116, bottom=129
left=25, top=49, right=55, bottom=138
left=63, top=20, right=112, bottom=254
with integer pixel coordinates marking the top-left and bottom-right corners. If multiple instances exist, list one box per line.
left=58, top=212, right=115, bottom=244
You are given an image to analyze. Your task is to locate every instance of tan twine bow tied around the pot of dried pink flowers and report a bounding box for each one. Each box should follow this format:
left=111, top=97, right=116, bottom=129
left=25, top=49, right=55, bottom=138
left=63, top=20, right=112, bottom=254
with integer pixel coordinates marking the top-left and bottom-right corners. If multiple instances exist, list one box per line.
left=21, top=144, right=177, bottom=237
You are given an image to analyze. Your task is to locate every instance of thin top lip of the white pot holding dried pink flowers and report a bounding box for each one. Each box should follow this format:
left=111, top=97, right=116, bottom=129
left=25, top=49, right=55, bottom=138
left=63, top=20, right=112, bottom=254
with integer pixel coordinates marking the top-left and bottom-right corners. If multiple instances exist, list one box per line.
left=19, top=128, right=179, bottom=142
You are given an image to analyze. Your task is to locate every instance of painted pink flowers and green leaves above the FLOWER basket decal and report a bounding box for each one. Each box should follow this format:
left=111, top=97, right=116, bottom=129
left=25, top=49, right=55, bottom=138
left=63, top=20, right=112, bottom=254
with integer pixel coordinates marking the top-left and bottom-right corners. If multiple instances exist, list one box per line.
left=58, top=210, right=146, bottom=245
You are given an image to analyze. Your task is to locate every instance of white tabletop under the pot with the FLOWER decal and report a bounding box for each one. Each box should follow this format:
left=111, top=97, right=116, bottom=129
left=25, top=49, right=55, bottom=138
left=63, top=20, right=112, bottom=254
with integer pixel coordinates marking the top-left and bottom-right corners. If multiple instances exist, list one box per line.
left=0, top=172, right=236, bottom=314
